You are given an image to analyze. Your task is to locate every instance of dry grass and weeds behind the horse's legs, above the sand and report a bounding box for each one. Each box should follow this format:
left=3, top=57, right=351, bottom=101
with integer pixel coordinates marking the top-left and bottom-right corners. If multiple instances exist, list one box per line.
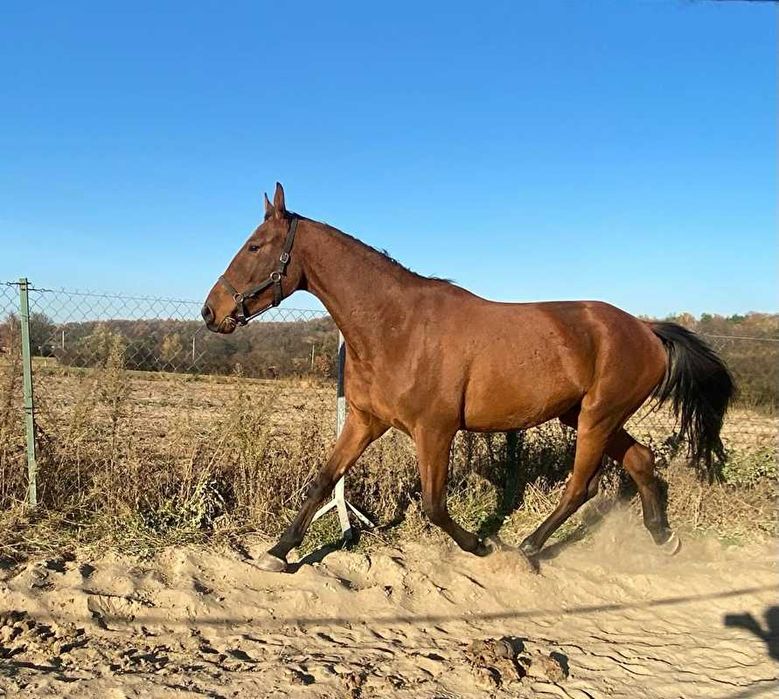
left=0, top=333, right=777, bottom=558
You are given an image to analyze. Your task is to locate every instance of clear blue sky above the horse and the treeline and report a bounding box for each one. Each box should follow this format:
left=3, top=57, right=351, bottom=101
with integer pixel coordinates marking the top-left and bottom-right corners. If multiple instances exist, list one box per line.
left=0, top=0, right=777, bottom=315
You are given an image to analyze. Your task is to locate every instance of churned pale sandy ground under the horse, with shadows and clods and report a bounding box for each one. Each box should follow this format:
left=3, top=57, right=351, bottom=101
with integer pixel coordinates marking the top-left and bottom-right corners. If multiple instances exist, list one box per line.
left=0, top=512, right=779, bottom=699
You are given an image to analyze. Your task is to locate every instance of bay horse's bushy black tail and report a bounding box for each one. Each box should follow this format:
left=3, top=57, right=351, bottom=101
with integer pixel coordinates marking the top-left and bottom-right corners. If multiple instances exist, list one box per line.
left=651, top=323, right=735, bottom=480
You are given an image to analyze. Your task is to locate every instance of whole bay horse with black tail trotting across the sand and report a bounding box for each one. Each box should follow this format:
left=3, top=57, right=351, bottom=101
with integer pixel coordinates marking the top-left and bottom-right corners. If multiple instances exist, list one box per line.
left=202, top=183, right=734, bottom=571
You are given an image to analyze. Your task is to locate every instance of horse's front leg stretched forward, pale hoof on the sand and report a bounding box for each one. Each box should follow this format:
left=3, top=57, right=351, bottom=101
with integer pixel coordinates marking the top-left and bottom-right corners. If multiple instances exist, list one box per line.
left=258, top=410, right=389, bottom=572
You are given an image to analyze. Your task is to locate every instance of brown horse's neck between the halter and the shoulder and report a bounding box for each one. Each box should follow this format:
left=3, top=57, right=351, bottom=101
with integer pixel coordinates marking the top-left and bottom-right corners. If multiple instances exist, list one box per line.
left=300, top=221, right=422, bottom=359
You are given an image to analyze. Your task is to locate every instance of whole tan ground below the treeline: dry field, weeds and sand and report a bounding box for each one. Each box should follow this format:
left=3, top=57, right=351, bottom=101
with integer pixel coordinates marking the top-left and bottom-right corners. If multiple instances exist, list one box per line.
left=0, top=357, right=779, bottom=697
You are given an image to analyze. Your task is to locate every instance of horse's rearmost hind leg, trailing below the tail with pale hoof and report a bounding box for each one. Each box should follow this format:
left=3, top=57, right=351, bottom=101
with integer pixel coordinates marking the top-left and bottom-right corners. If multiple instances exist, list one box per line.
left=606, top=429, right=680, bottom=555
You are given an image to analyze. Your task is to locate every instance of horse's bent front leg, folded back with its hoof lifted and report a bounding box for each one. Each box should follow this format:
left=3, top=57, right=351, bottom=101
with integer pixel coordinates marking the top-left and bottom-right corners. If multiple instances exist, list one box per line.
left=414, top=430, right=492, bottom=556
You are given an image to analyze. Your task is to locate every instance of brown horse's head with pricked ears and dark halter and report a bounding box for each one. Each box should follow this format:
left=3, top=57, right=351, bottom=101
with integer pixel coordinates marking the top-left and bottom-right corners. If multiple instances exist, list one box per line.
left=201, top=182, right=302, bottom=333
